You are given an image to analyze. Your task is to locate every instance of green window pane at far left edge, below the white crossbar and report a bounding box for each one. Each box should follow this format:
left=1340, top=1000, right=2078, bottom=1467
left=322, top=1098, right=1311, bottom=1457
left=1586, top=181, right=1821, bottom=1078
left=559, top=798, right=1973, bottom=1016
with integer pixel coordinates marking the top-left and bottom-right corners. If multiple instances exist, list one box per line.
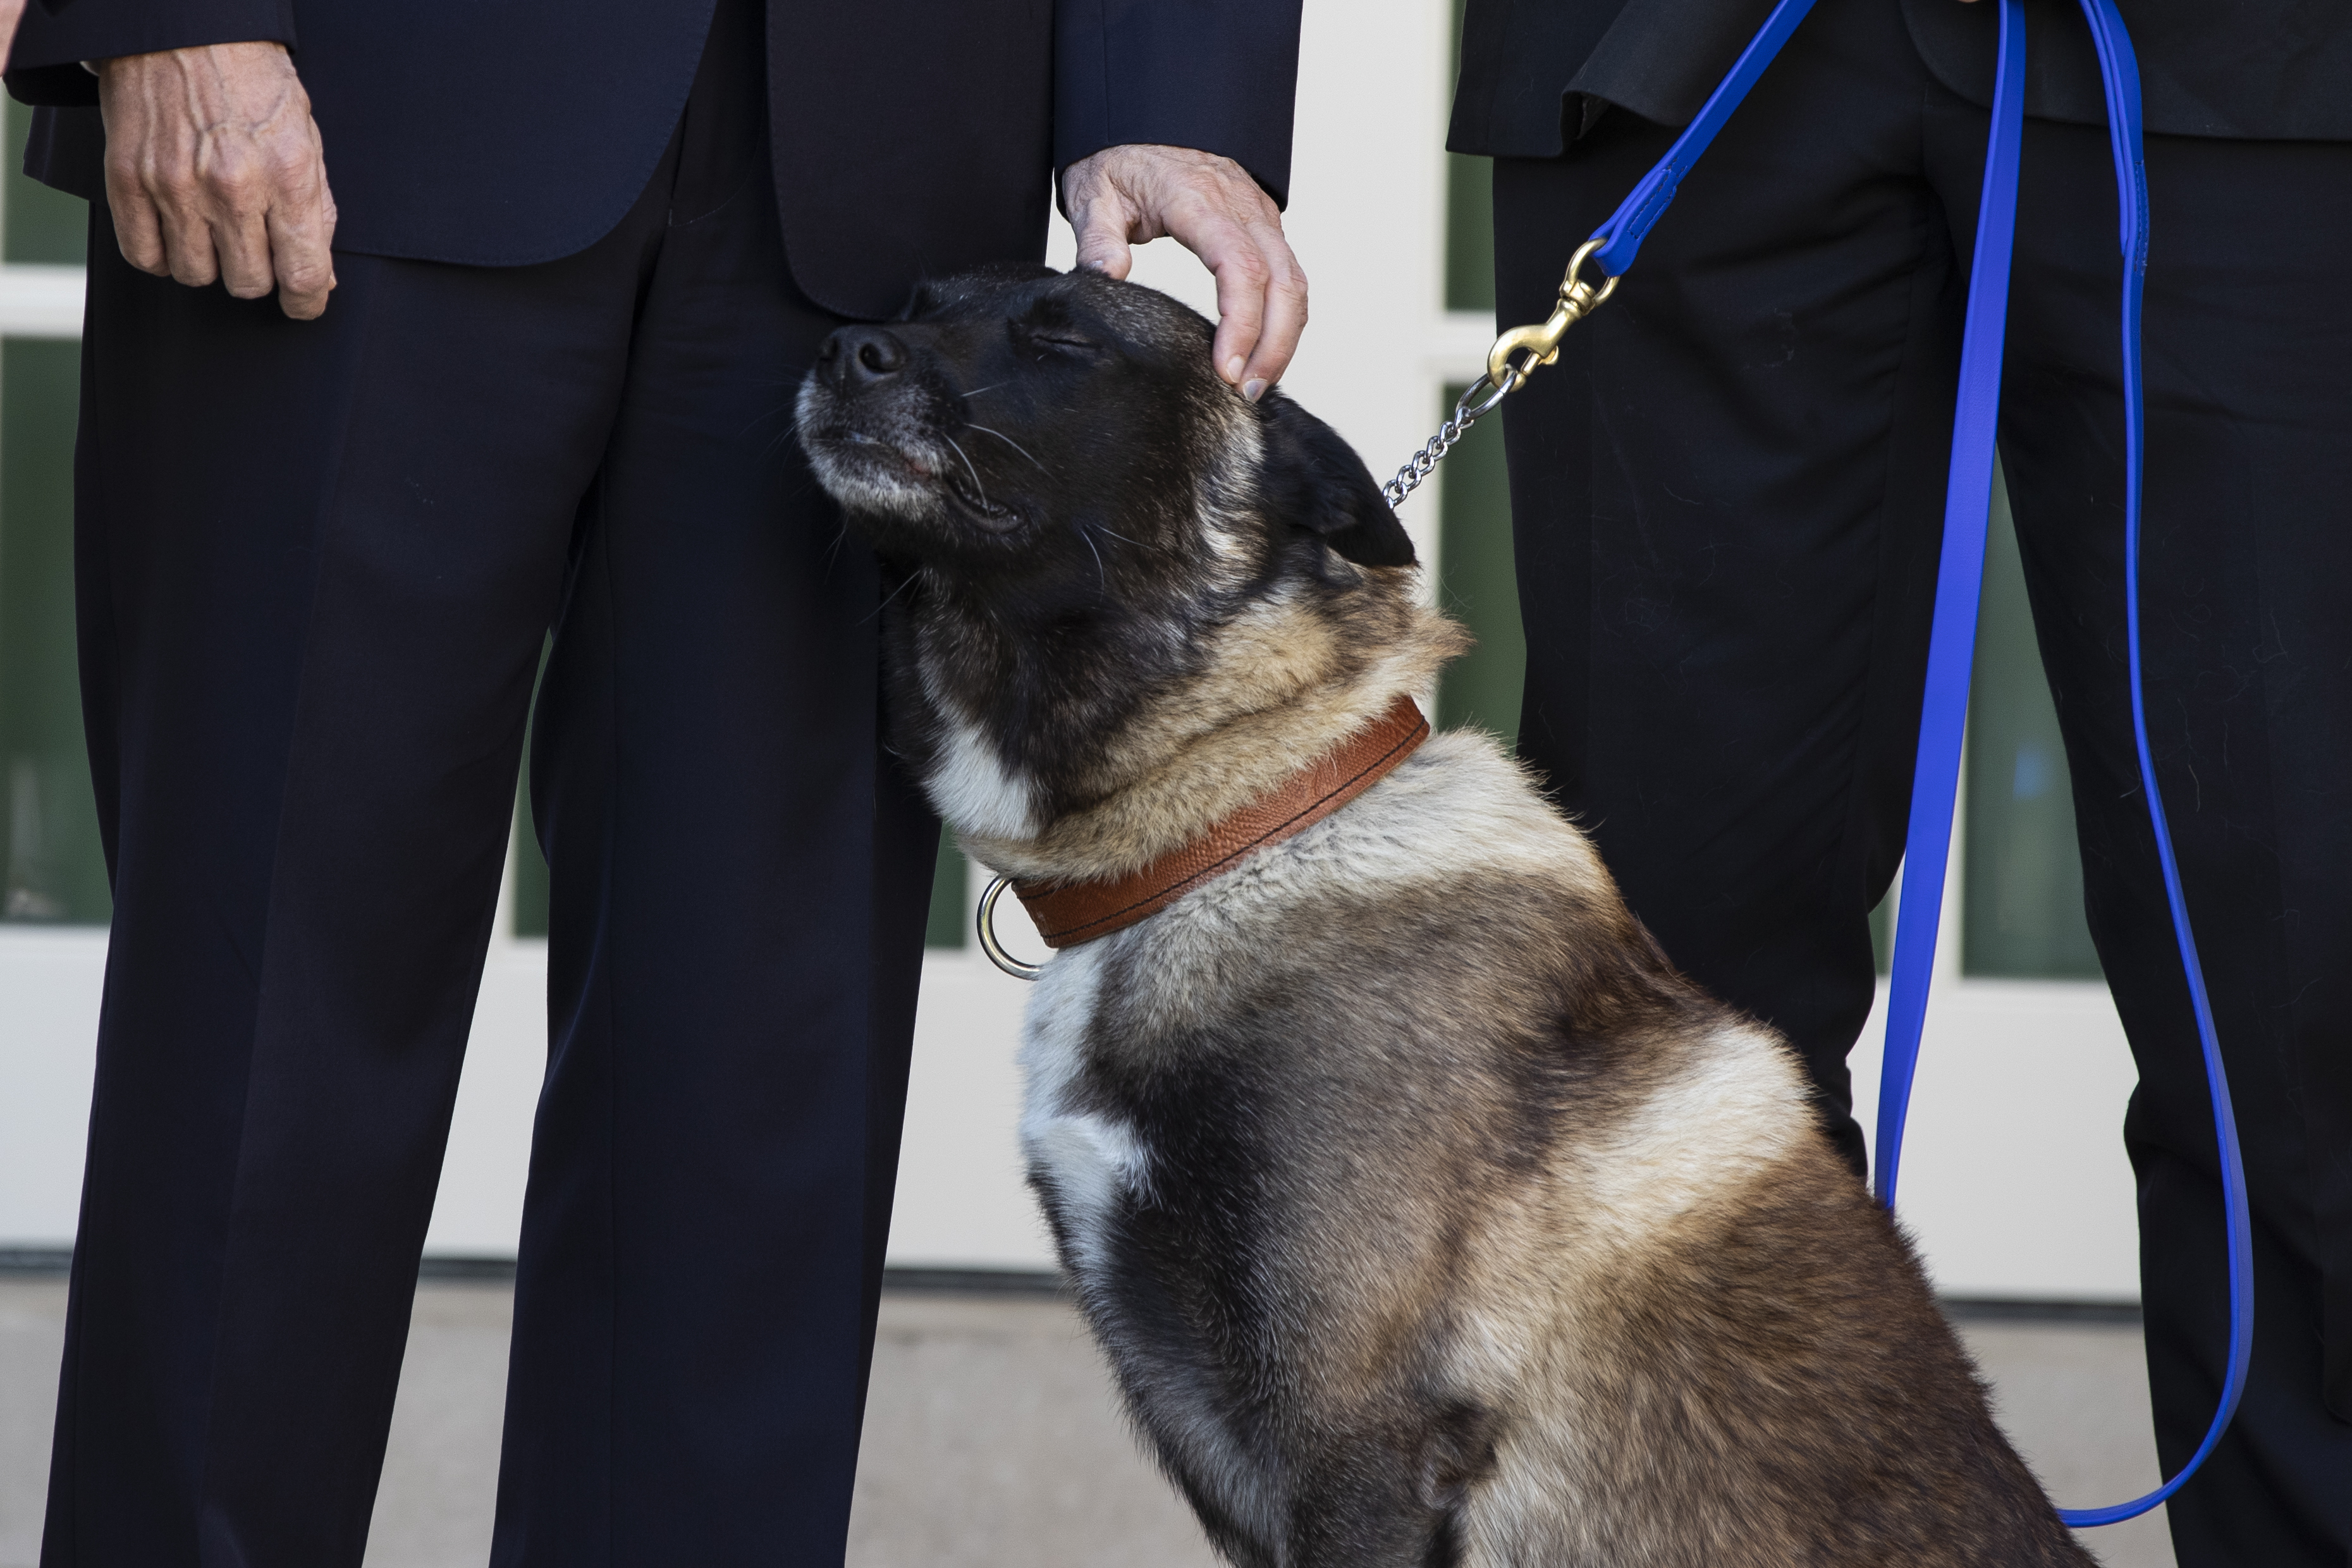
left=0, top=338, right=113, bottom=926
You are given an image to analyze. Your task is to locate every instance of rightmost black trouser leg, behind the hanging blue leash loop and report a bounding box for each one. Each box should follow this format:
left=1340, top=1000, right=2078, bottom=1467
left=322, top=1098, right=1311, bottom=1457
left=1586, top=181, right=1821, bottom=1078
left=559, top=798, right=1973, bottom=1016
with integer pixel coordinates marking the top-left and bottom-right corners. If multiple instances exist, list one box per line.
left=2002, top=122, right=2352, bottom=1568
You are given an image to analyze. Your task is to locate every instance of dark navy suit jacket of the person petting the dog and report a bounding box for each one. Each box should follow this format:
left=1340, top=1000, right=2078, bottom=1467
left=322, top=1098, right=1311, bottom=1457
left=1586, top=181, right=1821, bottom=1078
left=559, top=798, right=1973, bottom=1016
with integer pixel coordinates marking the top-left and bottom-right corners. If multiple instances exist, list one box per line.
left=9, top=0, right=1298, bottom=317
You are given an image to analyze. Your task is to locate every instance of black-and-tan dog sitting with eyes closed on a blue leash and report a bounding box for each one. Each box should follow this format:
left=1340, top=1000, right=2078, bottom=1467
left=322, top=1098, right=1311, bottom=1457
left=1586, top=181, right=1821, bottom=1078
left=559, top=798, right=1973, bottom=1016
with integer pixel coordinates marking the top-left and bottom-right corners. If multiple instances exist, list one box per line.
left=797, top=268, right=2093, bottom=1568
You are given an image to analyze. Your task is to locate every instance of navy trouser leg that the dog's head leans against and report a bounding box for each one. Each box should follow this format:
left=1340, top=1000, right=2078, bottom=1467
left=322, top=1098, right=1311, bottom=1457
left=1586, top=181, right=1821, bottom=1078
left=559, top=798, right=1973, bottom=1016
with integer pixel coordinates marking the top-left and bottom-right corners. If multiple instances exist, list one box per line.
left=491, top=4, right=938, bottom=1568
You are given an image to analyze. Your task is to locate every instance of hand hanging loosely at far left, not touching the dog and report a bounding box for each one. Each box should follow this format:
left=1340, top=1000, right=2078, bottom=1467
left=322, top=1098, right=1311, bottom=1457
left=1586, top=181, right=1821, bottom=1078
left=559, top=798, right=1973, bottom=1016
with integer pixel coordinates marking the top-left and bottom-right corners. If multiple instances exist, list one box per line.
left=99, top=42, right=334, bottom=322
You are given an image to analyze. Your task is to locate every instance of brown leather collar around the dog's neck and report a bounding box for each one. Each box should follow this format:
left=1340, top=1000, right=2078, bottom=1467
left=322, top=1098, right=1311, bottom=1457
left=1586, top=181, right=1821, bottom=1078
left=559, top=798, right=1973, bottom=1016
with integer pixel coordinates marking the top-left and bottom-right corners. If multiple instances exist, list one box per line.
left=1014, top=696, right=1430, bottom=947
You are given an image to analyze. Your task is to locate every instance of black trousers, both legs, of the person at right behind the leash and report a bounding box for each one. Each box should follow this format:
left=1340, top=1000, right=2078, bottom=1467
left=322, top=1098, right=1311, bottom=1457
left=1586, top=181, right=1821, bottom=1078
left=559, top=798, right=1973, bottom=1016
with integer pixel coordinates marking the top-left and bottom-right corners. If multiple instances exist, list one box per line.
left=1496, top=0, right=2352, bottom=1568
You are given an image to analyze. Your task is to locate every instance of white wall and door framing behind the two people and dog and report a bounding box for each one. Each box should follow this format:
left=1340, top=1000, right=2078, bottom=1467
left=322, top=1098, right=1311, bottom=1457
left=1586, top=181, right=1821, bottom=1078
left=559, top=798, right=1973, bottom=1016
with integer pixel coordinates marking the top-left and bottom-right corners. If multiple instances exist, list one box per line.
left=0, top=0, right=2138, bottom=1300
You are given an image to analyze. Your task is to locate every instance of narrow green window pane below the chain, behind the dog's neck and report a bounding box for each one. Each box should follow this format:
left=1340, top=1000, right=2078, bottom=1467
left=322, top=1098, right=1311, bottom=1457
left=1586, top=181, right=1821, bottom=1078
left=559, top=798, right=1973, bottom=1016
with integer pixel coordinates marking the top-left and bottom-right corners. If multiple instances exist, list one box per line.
left=1437, top=386, right=1526, bottom=743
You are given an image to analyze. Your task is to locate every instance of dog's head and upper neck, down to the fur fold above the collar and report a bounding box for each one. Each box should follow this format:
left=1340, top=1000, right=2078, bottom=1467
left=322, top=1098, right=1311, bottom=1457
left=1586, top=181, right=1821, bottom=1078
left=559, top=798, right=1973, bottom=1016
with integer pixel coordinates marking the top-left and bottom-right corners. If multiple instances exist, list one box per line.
left=800, top=268, right=1458, bottom=865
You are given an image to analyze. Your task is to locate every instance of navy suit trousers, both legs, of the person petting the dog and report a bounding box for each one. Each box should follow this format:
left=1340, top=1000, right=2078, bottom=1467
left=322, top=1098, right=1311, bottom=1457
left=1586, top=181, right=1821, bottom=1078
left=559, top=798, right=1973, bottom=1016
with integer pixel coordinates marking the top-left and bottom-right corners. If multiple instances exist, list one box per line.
left=42, top=7, right=936, bottom=1568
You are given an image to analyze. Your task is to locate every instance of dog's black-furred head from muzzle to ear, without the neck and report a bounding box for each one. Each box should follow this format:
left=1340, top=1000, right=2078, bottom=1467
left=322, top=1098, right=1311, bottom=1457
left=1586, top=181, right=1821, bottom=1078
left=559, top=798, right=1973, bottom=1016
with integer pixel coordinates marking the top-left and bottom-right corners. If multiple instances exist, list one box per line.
left=800, top=268, right=1414, bottom=585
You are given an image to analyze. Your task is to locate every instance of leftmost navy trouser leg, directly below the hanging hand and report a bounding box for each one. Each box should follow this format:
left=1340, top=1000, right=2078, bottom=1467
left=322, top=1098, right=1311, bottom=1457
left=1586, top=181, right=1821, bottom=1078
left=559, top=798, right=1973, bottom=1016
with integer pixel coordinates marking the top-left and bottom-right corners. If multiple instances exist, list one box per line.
left=42, top=184, right=661, bottom=1568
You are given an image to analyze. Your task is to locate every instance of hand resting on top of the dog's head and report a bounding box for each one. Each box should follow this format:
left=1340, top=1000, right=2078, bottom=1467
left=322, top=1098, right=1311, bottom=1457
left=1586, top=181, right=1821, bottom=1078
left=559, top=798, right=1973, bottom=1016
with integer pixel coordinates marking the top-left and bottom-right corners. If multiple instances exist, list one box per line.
left=1061, top=144, right=1308, bottom=402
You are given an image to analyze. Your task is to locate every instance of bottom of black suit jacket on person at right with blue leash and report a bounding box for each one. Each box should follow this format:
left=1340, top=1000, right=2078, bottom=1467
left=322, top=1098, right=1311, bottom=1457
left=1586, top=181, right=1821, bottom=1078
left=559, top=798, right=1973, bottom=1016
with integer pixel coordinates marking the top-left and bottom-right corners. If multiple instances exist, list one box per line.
left=1447, top=0, right=2352, bottom=157
